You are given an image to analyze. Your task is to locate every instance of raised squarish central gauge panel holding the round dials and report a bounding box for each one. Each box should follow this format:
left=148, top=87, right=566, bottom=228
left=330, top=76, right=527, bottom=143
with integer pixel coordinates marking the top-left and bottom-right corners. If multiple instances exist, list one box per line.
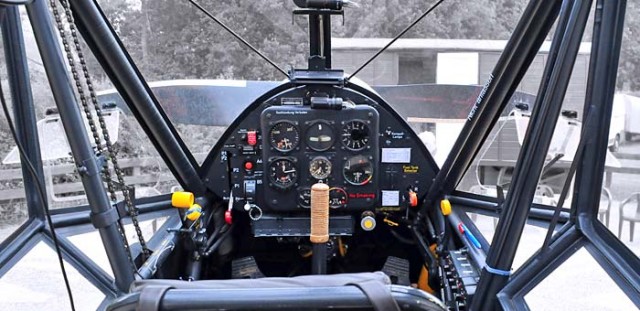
left=260, top=105, right=379, bottom=211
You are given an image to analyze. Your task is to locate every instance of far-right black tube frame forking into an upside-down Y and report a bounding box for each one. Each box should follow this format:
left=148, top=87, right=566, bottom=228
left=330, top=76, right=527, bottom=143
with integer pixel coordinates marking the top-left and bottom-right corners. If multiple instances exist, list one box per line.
left=498, top=0, right=640, bottom=310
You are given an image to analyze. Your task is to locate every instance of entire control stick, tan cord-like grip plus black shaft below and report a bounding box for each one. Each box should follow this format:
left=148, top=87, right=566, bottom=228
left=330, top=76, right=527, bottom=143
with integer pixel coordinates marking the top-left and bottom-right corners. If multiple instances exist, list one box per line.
left=310, top=183, right=329, bottom=274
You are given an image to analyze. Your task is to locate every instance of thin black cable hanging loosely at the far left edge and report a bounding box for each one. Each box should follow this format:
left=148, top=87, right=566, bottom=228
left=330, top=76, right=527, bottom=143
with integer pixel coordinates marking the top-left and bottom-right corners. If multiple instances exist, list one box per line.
left=0, top=83, right=76, bottom=311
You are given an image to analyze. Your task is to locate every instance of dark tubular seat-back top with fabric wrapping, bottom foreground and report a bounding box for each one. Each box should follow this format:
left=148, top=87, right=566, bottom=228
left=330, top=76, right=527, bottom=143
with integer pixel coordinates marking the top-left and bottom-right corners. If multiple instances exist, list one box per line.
left=106, top=272, right=446, bottom=311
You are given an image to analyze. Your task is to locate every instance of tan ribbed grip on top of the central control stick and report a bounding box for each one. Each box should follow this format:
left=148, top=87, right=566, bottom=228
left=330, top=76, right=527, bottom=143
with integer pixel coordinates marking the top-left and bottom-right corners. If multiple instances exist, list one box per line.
left=311, top=183, right=329, bottom=243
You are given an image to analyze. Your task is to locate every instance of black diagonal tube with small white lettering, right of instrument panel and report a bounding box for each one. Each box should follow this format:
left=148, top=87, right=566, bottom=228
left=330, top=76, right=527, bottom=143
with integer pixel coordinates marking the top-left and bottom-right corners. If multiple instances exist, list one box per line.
left=424, top=0, right=561, bottom=210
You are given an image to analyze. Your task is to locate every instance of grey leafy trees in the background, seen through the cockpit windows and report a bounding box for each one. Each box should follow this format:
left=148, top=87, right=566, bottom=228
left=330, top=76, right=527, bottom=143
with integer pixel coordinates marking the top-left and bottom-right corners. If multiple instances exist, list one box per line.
left=89, top=0, right=640, bottom=90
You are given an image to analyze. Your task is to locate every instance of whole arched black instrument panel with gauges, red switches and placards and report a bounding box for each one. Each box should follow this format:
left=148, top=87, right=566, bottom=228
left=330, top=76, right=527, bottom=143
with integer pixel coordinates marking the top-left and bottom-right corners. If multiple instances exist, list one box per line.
left=203, top=85, right=437, bottom=225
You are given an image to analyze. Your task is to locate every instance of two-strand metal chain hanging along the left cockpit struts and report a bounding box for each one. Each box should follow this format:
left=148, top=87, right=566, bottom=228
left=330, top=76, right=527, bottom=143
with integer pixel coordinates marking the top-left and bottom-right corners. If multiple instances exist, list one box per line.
left=50, top=0, right=149, bottom=271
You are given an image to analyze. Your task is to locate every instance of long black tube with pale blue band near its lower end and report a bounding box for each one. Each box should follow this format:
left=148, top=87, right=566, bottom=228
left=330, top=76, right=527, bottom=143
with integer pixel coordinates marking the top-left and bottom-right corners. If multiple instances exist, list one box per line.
left=471, top=0, right=591, bottom=310
